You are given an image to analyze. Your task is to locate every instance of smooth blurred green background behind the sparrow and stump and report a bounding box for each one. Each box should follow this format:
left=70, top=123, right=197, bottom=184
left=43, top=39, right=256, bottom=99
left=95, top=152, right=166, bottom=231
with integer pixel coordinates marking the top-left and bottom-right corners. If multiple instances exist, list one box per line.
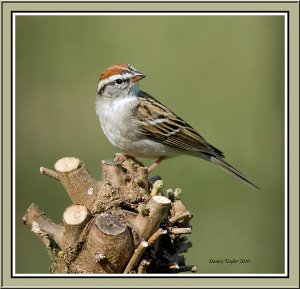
left=16, top=16, right=284, bottom=273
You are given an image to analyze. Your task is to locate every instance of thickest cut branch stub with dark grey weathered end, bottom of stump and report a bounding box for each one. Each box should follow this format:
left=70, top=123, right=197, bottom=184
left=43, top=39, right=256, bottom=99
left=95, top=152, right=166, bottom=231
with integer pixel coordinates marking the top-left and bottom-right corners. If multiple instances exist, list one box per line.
left=71, top=213, right=134, bottom=273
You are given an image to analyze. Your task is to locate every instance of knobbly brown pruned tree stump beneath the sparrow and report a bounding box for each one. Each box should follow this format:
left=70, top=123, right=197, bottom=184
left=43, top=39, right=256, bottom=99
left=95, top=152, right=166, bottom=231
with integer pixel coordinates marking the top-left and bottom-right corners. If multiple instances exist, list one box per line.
left=23, top=157, right=197, bottom=274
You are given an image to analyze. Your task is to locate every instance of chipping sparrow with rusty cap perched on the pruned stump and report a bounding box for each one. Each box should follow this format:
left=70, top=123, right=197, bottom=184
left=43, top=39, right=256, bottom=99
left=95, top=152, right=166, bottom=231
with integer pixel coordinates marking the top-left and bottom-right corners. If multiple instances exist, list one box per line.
left=96, top=64, right=258, bottom=189
